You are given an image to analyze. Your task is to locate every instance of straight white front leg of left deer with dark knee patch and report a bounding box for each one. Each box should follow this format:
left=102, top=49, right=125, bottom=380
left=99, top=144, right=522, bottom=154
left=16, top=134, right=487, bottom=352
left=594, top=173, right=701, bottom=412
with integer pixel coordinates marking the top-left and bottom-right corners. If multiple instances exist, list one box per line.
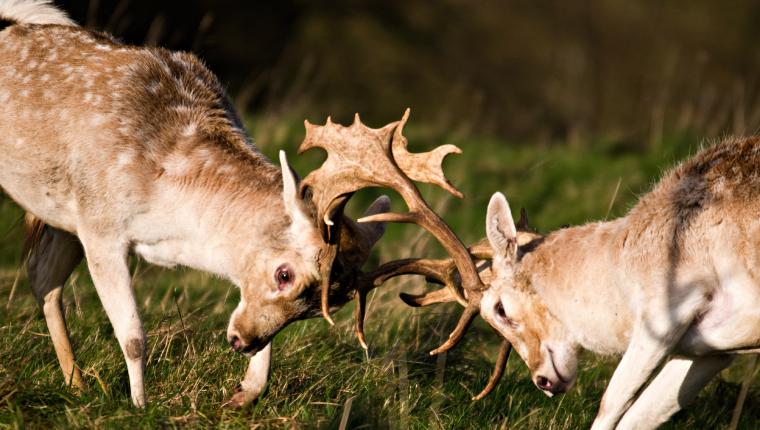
left=79, top=233, right=145, bottom=407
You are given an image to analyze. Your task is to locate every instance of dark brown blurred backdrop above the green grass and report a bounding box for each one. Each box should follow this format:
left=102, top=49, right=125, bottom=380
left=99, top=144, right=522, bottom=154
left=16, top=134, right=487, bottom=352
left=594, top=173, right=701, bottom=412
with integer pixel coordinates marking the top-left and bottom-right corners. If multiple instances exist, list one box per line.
left=56, top=0, right=760, bottom=146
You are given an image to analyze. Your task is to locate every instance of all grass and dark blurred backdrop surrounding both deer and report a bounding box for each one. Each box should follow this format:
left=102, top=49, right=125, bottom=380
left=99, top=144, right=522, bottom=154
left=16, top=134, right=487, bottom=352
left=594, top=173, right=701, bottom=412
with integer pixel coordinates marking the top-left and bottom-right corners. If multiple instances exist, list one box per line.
left=0, top=0, right=760, bottom=429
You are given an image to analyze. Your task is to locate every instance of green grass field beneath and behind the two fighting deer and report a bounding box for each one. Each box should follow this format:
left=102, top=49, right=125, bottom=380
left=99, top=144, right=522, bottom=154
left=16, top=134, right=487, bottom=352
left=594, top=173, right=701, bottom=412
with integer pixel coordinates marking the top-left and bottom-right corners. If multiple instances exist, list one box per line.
left=0, top=123, right=760, bottom=429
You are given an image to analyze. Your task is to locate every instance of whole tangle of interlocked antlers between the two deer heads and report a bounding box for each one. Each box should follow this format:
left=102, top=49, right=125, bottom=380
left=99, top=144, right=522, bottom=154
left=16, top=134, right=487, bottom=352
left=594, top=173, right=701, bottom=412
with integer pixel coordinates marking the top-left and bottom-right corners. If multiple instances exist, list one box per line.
left=299, top=109, right=511, bottom=399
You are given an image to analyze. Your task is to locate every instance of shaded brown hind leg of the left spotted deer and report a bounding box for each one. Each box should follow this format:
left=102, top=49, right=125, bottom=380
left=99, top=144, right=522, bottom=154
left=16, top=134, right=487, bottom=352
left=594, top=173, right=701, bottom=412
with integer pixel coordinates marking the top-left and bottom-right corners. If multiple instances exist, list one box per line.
left=27, top=226, right=85, bottom=391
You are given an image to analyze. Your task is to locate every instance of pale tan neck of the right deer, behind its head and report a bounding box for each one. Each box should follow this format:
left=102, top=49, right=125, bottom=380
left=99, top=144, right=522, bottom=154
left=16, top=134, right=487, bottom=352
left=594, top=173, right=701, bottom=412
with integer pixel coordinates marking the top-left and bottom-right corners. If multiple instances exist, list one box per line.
left=521, top=218, right=635, bottom=354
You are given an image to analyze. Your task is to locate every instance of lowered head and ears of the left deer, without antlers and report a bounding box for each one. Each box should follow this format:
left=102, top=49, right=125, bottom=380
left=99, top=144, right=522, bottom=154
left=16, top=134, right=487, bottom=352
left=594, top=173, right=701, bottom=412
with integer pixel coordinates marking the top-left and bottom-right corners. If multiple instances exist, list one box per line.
left=227, top=152, right=390, bottom=355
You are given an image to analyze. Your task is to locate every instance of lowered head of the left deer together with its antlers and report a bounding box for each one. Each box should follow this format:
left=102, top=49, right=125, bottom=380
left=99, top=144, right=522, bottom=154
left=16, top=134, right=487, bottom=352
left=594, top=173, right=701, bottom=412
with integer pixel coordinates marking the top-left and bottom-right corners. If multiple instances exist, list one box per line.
left=227, top=110, right=470, bottom=354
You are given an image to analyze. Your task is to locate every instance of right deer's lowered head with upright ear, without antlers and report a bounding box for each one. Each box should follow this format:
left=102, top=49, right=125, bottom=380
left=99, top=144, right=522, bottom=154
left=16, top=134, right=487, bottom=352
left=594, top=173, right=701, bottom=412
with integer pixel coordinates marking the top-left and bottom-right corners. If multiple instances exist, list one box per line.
left=480, top=193, right=577, bottom=396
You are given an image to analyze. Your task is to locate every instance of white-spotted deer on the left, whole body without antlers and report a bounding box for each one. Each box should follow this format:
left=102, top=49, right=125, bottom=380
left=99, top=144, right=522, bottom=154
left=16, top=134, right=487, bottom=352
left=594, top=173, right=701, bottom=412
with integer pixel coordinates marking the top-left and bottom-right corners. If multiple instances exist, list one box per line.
left=0, top=0, right=400, bottom=406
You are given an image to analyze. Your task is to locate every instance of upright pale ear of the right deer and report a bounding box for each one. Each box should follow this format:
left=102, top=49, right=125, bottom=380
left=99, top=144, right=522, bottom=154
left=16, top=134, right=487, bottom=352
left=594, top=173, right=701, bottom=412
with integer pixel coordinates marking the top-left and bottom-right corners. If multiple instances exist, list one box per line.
left=486, top=193, right=517, bottom=263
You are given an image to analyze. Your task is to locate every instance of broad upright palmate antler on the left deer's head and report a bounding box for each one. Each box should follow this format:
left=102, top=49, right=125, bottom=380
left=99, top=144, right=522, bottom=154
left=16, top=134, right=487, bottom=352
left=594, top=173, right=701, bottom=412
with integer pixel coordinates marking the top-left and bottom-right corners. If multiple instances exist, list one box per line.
left=299, top=109, right=485, bottom=330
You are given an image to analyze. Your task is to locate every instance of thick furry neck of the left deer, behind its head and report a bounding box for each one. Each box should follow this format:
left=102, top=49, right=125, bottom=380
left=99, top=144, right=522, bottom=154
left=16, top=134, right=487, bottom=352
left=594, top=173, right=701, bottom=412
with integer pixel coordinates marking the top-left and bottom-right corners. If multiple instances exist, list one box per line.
left=131, top=141, right=288, bottom=285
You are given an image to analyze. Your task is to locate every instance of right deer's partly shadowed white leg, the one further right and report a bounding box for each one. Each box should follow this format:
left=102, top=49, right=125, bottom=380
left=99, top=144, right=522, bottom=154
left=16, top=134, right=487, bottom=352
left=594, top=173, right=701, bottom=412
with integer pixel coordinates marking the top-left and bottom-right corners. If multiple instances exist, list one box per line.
left=617, top=355, right=734, bottom=430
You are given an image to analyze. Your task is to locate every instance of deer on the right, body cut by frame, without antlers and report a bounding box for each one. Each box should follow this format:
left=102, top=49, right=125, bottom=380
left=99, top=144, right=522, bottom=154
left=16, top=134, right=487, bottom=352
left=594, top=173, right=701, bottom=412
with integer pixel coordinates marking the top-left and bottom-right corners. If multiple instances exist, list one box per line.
left=472, top=138, right=760, bottom=429
